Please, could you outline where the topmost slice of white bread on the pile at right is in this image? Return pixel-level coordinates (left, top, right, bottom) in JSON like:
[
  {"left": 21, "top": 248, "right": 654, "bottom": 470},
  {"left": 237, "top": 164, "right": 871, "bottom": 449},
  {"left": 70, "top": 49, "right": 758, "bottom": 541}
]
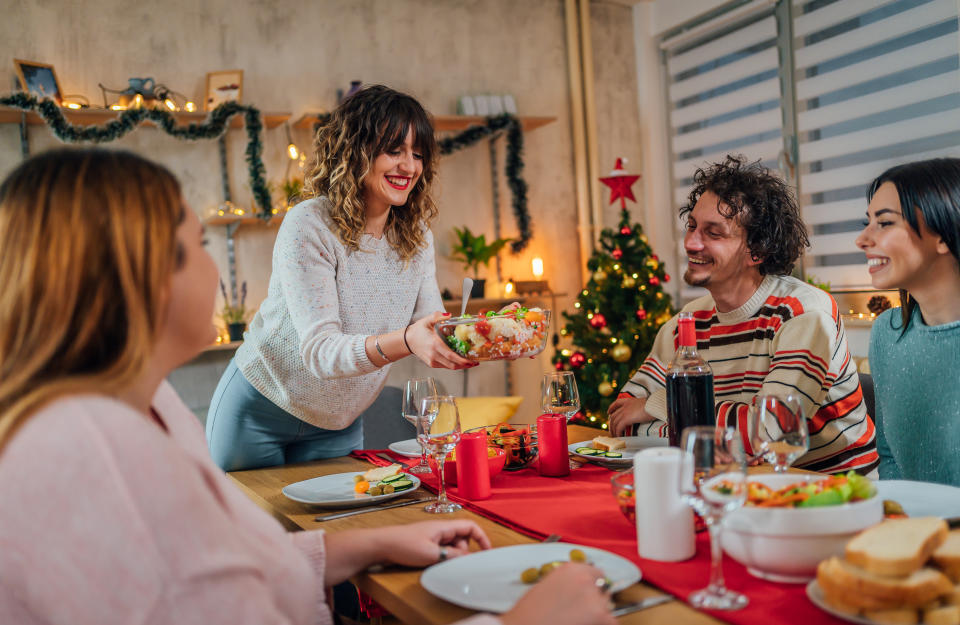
[{"left": 846, "top": 517, "right": 947, "bottom": 576}]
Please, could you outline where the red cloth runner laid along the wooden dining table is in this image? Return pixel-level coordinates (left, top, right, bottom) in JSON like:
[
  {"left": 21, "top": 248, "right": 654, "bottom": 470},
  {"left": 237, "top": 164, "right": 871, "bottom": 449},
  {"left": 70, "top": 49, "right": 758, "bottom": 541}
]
[{"left": 351, "top": 450, "right": 844, "bottom": 625}]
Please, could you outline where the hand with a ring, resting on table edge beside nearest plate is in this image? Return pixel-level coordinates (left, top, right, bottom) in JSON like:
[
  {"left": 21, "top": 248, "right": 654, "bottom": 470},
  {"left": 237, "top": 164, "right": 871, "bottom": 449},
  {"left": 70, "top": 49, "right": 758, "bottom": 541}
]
[{"left": 381, "top": 520, "right": 490, "bottom": 567}]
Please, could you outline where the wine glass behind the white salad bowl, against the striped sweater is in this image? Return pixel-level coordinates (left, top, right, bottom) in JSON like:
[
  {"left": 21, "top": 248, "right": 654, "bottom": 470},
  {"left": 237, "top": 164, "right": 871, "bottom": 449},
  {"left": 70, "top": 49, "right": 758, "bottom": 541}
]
[{"left": 747, "top": 395, "right": 810, "bottom": 473}]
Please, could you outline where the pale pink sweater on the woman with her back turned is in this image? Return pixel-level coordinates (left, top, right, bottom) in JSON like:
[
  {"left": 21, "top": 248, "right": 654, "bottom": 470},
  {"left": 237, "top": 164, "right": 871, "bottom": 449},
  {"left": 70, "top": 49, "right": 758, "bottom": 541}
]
[{"left": 0, "top": 383, "right": 499, "bottom": 625}]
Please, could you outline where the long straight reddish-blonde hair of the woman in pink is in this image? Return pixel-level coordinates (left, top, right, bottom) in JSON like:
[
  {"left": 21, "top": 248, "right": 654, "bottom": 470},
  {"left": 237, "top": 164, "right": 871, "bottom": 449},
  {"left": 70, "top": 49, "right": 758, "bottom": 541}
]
[{"left": 0, "top": 149, "right": 184, "bottom": 450}]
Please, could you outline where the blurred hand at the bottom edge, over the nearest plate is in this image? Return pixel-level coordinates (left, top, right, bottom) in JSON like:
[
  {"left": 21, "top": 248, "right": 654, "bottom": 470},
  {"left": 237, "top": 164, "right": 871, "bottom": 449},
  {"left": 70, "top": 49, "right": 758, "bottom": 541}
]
[{"left": 500, "top": 562, "right": 617, "bottom": 625}]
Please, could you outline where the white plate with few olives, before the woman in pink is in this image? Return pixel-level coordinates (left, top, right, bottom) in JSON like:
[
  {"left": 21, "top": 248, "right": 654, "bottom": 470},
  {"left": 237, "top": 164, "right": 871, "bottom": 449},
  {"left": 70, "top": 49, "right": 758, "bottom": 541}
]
[{"left": 420, "top": 543, "right": 640, "bottom": 613}]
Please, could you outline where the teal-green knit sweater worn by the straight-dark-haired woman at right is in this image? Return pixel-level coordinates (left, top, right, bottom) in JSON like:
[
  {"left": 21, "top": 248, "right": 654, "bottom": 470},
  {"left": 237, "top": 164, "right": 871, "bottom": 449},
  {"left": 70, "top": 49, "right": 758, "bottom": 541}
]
[{"left": 870, "top": 307, "right": 960, "bottom": 486}]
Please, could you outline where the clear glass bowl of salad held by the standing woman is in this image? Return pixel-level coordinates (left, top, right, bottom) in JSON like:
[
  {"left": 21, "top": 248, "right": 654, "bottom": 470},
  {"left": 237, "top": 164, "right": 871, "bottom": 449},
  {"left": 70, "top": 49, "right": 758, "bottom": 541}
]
[{"left": 434, "top": 306, "right": 550, "bottom": 361}]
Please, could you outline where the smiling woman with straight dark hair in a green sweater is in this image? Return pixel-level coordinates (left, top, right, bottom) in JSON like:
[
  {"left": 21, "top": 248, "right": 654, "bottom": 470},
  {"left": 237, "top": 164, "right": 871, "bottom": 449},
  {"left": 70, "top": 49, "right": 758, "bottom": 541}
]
[{"left": 857, "top": 158, "right": 960, "bottom": 486}]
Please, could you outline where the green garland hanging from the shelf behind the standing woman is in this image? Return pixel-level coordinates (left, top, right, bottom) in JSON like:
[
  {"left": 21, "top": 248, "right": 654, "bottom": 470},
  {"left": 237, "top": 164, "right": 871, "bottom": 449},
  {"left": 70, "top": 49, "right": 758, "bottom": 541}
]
[{"left": 314, "top": 113, "right": 533, "bottom": 254}]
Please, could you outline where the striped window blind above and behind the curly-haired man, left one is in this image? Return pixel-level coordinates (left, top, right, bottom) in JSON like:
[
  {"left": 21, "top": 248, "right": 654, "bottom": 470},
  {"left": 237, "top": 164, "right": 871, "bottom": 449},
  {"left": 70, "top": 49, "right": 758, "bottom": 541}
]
[{"left": 661, "top": 2, "right": 783, "bottom": 298}]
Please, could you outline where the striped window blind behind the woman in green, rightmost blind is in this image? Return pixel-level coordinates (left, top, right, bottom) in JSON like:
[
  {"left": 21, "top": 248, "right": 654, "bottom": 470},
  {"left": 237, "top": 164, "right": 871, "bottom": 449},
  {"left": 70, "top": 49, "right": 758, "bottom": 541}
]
[{"left": 792, "top": 0, "right": 960, "bottom": 288}]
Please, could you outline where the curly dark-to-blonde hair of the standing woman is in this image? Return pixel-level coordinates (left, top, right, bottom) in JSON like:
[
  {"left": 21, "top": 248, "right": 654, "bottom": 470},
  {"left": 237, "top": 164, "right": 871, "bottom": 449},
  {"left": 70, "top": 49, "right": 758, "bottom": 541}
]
[{"left": 304, "top": 85, "right": 438, "bottom": 262}]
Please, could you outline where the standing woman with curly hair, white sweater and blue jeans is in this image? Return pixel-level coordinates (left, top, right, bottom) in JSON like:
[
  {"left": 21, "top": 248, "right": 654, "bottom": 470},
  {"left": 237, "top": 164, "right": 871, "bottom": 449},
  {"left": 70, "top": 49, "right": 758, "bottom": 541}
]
[{"left": 207, "top": 85, "right": 474, "bottom": 471}]
